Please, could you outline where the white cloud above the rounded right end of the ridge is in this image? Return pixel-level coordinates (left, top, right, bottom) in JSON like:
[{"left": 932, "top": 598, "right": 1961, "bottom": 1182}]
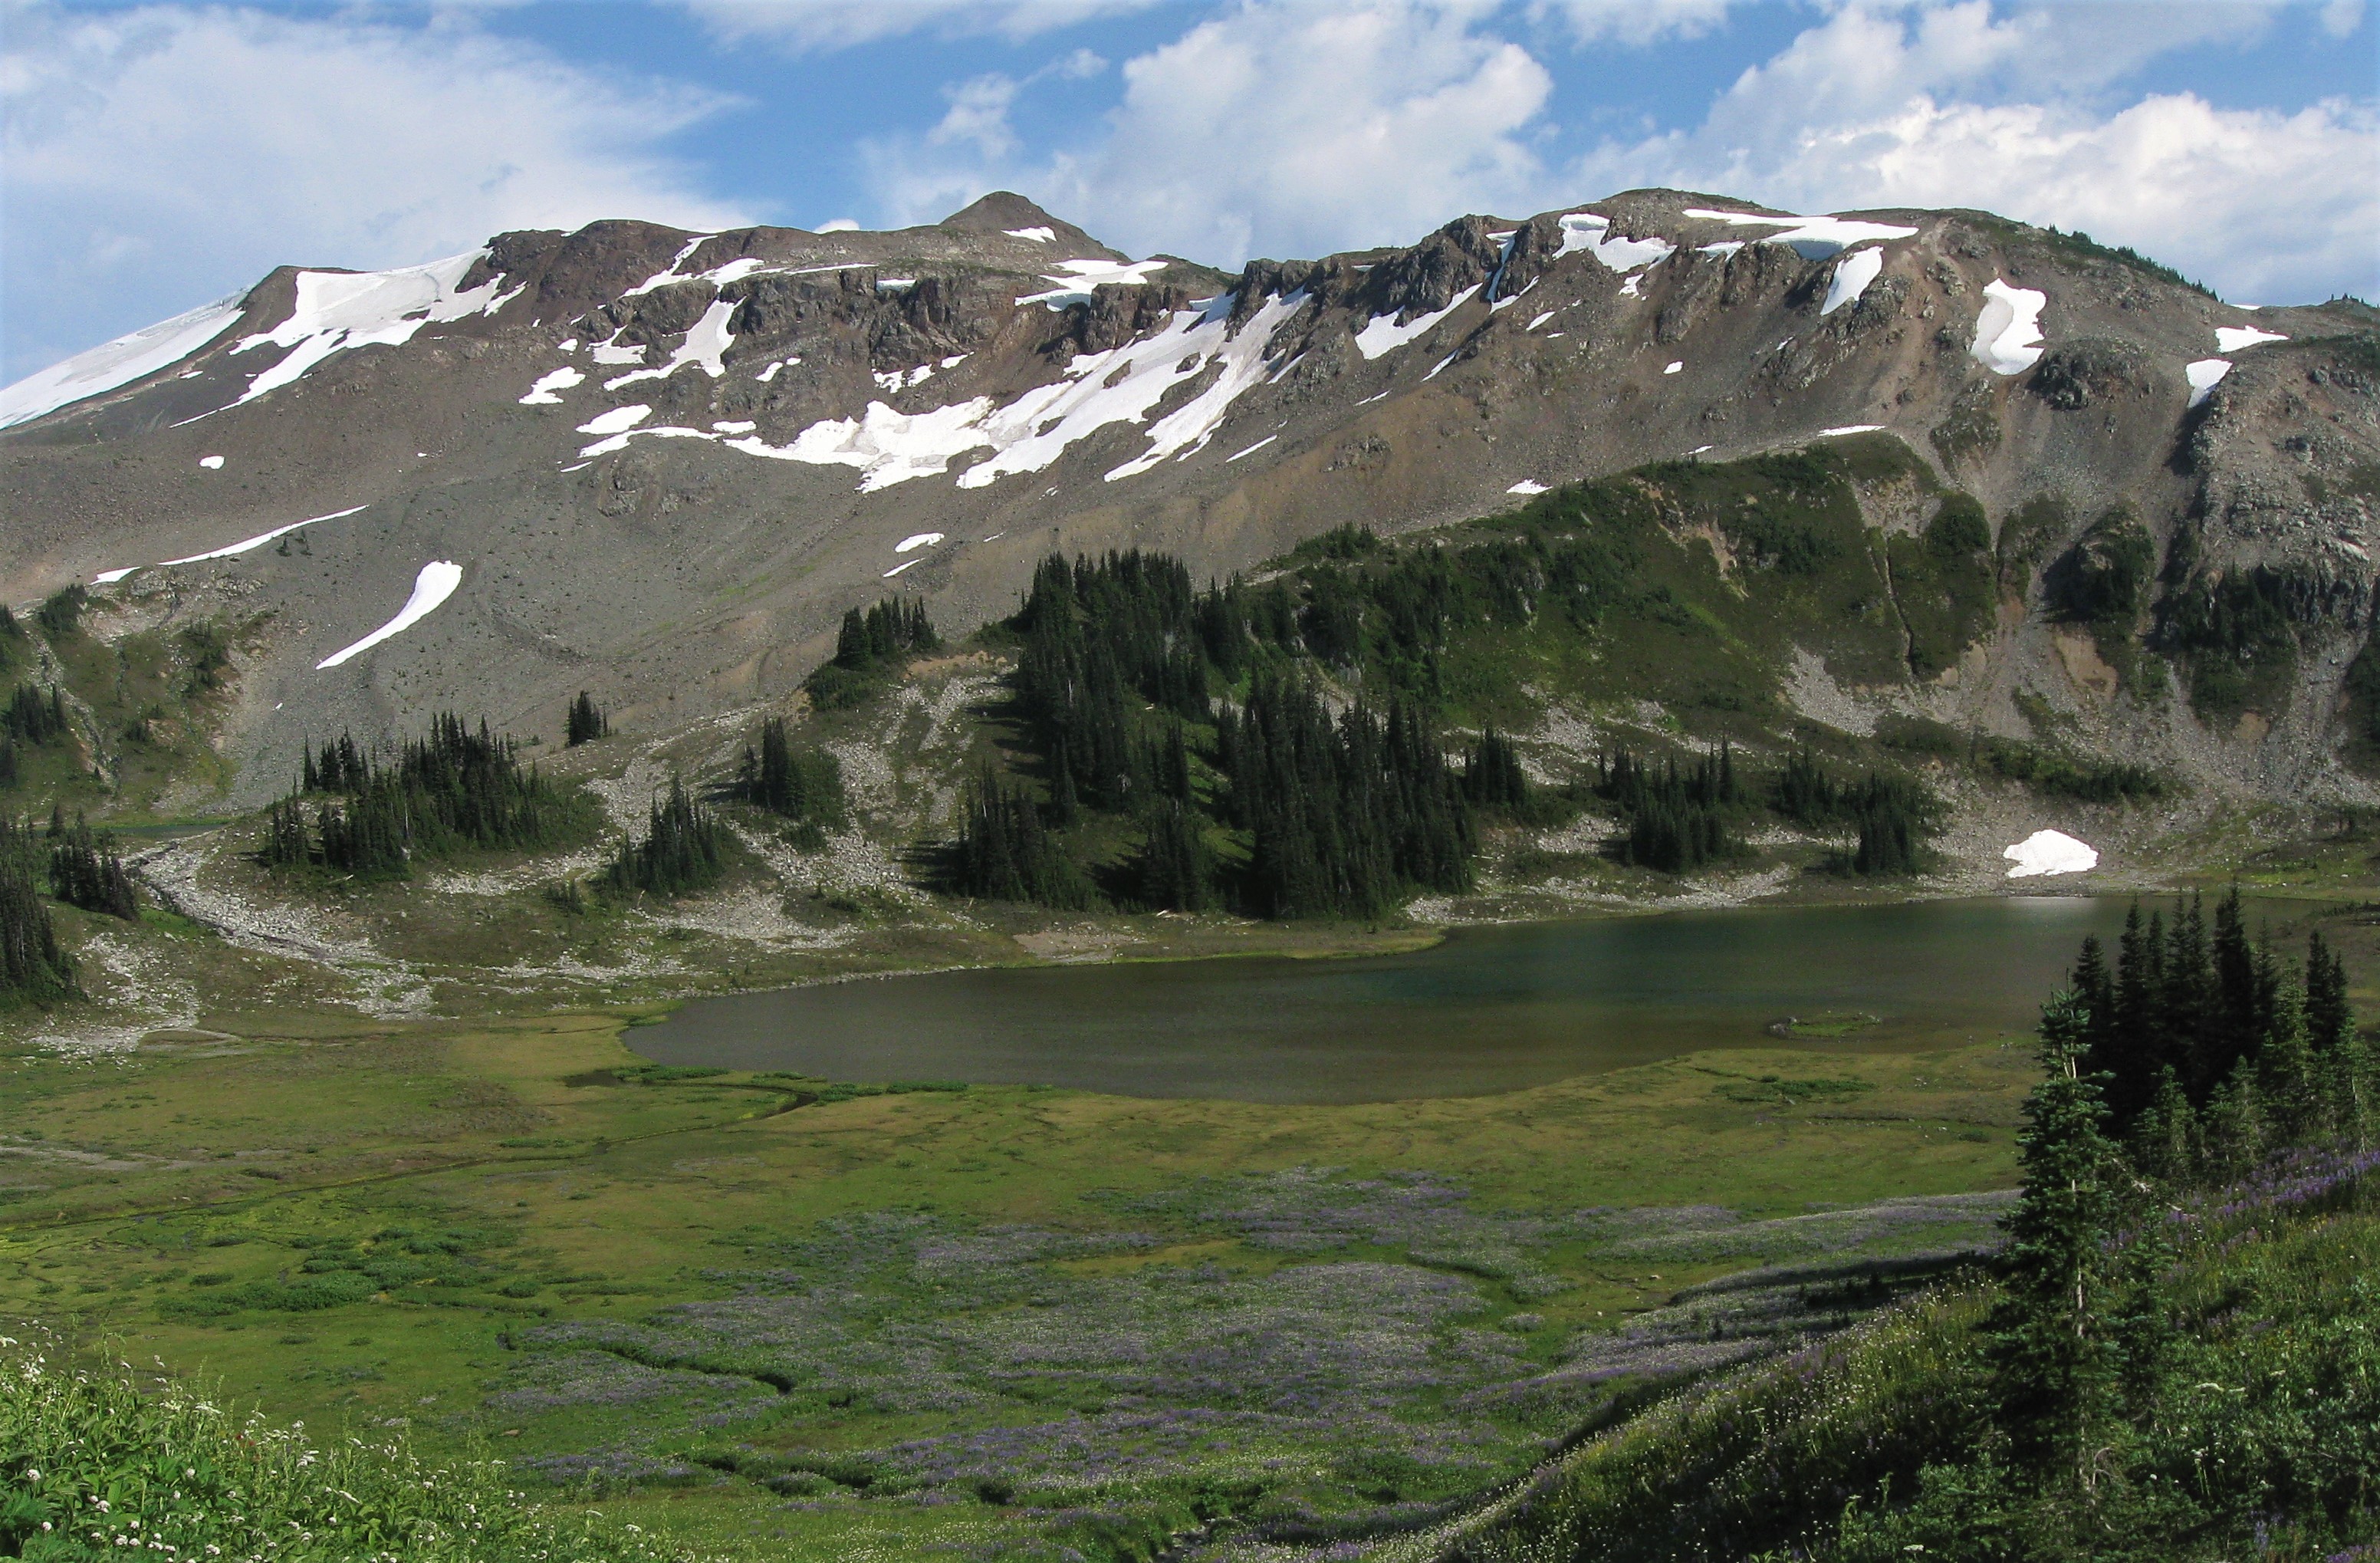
[{"left": 1573, "top": 5, "right": 2380, "bottom": 302}]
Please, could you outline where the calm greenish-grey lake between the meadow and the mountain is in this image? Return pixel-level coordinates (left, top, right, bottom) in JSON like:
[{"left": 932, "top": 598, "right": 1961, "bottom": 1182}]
[{"left": 633, "top": 897, "right": 2306, "bottom": 1101}]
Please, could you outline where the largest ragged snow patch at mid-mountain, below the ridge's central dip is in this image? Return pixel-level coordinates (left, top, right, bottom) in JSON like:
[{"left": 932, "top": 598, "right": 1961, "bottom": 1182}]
[{"left": 728, "top": 293, "right": 1307, "bottom": 492}]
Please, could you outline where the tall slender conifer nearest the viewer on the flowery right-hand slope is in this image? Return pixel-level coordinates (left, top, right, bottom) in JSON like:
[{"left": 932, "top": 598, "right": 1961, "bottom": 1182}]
[{"left": 1990, "top": 989, "right": 2113, "bottom": 1479}]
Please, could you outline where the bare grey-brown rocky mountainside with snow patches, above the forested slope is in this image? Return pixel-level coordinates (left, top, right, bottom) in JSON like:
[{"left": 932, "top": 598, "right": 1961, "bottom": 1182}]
[{"left": 0, "top": 190, "right": 2380, "bottom": 799}]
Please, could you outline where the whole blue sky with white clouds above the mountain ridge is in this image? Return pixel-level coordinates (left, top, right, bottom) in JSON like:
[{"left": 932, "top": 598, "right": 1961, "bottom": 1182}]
[{"left": 0, "top": 0, "right": 2380, "bottom": 380}]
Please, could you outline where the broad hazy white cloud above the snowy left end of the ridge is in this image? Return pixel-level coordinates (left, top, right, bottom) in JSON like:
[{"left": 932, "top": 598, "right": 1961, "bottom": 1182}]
[{"left": 0, "top": 7, "right": 750, "bottom": 380}]
